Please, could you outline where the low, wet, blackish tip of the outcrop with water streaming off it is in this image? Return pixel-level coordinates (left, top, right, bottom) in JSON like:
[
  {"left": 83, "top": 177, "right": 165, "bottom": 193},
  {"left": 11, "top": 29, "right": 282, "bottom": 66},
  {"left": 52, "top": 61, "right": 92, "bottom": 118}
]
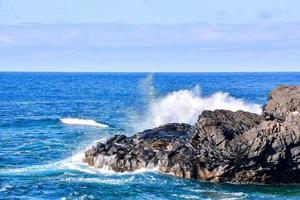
[{"left": 84, "top": 124, "right": 191, "bottom": 172}]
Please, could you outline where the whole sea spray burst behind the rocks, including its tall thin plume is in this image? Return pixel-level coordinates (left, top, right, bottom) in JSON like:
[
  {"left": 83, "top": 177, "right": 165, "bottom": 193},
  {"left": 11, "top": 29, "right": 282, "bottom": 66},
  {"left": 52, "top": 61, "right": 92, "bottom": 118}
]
[{"left": 129, "top": 73, "right": 262, "bottom": 132}]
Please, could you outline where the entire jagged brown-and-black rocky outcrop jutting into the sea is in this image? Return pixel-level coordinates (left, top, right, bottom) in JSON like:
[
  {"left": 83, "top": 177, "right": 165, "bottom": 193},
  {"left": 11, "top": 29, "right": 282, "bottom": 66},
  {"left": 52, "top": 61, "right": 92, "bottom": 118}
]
[{"left": 84, "top": 86, "right": 300, "bottom": 183}]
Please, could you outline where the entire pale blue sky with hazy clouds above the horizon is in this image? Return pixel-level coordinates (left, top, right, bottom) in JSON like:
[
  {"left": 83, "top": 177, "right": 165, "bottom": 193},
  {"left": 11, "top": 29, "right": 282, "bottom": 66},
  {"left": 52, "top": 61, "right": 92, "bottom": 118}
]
[{"left": 0, "top": 0, "right": 300, "bottom": 72}]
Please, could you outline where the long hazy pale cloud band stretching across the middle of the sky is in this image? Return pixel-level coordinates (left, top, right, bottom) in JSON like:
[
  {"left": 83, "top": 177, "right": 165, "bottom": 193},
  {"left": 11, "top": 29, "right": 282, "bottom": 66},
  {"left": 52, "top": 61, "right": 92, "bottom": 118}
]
[{"left": 0, "top": 22, "right": 300, "bottom": 51}]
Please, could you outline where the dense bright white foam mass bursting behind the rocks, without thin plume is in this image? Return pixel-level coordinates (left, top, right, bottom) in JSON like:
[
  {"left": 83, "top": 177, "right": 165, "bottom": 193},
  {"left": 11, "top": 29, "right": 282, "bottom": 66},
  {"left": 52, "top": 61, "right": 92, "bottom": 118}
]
[{"left": 150, "top": 86, "right": 262, "bottom": 126}]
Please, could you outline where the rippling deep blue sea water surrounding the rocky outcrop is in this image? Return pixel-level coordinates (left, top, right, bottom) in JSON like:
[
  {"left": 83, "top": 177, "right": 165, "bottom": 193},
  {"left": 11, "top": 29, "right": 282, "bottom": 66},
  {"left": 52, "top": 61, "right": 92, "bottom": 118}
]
[{"left": 0, "top": 72, "right": 300, "bottom": 200}]
